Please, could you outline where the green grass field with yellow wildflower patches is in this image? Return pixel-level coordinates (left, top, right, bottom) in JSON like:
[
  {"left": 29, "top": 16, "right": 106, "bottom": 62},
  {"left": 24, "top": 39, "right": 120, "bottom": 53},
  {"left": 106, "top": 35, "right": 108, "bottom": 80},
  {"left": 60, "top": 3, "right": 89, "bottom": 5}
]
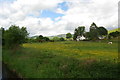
[{"left": 3, "top": 41, "right": 118, "bottom": 78}]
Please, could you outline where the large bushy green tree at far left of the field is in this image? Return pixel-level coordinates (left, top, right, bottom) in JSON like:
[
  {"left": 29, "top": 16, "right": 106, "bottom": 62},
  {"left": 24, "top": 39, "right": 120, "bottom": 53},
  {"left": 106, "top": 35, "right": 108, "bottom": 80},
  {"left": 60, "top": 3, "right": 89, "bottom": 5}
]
[{"left": 4, "top": 25, "right": 28, "bottom": 48}]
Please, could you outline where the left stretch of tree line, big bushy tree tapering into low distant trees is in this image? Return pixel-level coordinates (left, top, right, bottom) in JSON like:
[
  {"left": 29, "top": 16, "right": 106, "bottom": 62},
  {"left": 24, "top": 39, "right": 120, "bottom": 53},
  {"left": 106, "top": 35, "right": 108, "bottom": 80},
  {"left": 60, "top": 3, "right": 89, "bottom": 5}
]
[{"left": 0, "top": 25, "right": 65, "bottom": 48}]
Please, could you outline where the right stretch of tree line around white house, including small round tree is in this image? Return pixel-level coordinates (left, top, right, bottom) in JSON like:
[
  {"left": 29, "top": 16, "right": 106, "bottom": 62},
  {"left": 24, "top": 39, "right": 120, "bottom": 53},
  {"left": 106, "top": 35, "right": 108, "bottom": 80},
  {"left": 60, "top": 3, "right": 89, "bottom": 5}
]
[{"left": 66, "top": 22, "right": 120, "bottom": 41}]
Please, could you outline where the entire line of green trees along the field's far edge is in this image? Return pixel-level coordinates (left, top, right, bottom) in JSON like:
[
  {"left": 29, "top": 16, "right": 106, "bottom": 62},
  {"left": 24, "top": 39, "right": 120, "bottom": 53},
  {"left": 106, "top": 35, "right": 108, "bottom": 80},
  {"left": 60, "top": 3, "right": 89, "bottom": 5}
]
[{"left": 0, "top": 22, "right": 120, "bottom": 48}]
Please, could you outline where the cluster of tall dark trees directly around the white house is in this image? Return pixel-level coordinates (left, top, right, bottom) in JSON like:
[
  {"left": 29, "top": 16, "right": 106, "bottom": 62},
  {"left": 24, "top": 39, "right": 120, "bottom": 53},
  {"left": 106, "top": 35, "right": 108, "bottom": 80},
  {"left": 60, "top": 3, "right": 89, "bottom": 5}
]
[{"left": 73, "top": 22, "right": 108, "bottom": 40}]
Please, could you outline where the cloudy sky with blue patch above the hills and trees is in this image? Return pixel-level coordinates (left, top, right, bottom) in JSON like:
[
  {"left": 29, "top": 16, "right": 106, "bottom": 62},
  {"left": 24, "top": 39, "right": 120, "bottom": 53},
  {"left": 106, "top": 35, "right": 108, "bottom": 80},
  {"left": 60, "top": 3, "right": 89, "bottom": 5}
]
[{"left": 0, "top": 0, "right": 119, "bottom": 36}]
